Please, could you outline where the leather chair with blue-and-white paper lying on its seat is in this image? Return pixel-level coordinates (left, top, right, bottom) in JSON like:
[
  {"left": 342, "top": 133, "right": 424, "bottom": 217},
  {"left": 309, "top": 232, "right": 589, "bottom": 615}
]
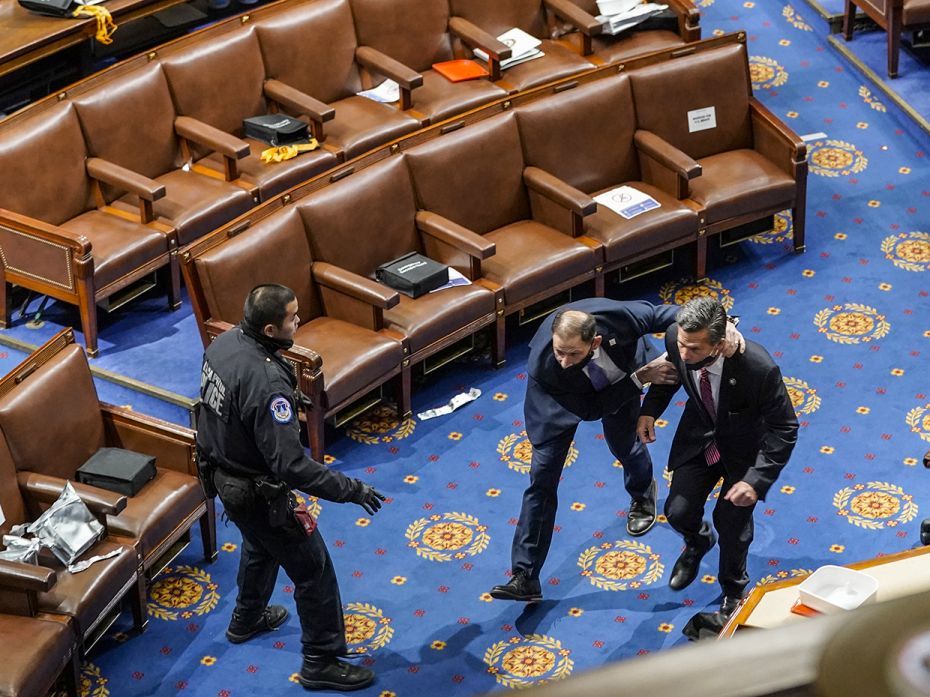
[{"left": 516, "top": 75, "right": 698, "bottom": 278}]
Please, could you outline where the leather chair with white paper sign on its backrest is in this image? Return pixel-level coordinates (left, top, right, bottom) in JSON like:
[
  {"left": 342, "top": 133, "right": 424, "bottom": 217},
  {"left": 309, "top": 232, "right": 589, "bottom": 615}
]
[{"left": 630, "top": 43, "right": 807, "bottom": 278}]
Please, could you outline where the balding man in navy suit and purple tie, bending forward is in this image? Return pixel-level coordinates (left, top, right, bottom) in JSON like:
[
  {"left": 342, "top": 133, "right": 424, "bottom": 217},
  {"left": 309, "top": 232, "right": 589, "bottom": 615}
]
[{"left": 491, "top": 298, "right": 744, "bottom": 601}]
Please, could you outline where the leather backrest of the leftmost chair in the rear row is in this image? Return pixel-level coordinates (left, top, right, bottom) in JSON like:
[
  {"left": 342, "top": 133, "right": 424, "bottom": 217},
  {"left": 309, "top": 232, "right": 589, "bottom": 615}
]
[{"left": 0, "top": 101, "right": 94, "bottom": 225}]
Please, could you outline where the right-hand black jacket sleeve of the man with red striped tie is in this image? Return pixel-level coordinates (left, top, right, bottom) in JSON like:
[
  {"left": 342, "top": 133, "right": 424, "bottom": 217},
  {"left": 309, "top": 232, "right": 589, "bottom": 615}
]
[{"left": 743, "top": 364, "right": 798, "bottom": 499}]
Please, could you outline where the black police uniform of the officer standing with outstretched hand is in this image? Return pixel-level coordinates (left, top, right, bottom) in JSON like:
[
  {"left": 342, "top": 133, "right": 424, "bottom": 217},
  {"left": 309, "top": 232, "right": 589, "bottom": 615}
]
[{"left": 197, "top": 324, "right": 365, "bottom": 656}]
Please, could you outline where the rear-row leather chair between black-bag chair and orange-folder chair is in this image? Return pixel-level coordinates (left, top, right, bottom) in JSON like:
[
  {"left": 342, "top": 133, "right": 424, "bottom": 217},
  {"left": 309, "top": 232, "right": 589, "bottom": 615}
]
[{"left": 255, "top": 0, "right": 421, "bottom": 159}]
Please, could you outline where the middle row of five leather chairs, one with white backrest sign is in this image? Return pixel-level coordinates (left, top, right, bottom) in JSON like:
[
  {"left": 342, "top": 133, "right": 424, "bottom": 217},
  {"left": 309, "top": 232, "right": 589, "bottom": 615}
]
[{"left": 182, "top": 34, "right": 807, "bottom": 457}]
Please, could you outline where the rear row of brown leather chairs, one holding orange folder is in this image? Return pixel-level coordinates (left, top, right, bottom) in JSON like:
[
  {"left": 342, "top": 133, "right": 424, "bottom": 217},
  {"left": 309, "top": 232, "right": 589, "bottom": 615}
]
[{"left": 0, "top": 0, "right": 700, "bottom": 356}]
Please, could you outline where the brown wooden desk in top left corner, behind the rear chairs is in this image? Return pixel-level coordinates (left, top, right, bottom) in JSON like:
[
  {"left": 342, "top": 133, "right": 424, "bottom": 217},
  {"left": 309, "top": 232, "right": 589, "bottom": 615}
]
[{"left": 0, "top": 0, "right": 187, "bottom": 77}]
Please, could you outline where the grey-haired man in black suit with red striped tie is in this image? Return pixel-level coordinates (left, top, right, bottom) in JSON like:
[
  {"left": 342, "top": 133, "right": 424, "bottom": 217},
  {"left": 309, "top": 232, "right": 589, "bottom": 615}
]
[{"left": 637, "top": 298, "right": 798, "bottom": 615}]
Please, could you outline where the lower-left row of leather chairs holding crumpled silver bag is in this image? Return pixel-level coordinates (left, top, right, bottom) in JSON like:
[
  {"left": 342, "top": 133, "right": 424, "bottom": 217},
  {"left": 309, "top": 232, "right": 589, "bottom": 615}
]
[{"left": 0, "top": 329, "right": 216, "bottom": 697}]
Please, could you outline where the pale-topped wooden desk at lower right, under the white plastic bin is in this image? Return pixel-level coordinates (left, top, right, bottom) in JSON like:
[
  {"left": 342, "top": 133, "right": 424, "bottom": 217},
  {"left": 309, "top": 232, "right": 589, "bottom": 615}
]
[{"left": 720, "top": 547, "right": 930, "bottom": 638}]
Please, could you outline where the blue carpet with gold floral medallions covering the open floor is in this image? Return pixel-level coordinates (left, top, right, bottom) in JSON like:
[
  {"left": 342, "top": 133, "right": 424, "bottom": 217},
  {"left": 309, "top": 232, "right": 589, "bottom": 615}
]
[{"left": 7, "top": 0, "right": 930, "bottom": 697}]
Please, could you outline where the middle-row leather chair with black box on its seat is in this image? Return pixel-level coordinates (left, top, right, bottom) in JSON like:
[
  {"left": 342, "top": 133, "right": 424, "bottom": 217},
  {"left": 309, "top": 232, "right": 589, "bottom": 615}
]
[{"left": 297, "top": 155, "right": 504, "bottom": 370}]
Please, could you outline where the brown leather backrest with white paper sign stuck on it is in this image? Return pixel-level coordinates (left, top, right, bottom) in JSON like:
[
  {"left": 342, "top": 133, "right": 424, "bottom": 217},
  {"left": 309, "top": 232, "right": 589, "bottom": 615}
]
[{"left": 630, "top": 44, "right": 753, "bottom": 160}]
